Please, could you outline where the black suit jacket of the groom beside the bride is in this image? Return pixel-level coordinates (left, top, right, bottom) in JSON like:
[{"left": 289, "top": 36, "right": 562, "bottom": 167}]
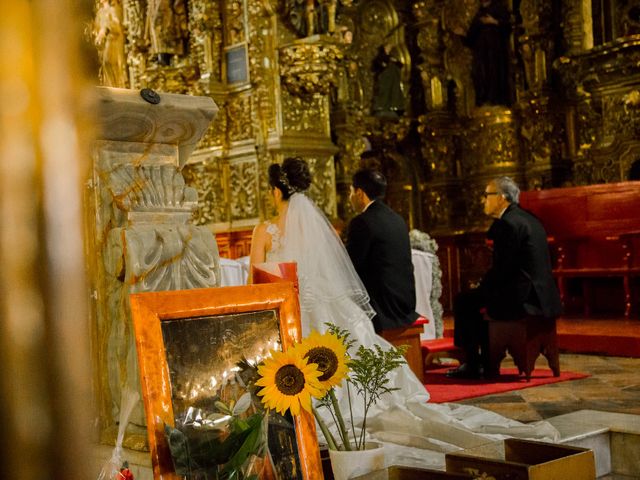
[{"left": 347, "top": 200, "right": 419, "bottom": 332}]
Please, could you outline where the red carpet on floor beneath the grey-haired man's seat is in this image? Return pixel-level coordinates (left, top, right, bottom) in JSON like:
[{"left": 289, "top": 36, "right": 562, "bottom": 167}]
[{"left": 424, "top": 366, "right": 589, "bottom": 403}]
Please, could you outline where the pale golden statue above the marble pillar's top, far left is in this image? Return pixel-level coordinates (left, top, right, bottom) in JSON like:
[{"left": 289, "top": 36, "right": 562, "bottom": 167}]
[{"left": 93, "top": 0, "right": 127, "bottom": 88}]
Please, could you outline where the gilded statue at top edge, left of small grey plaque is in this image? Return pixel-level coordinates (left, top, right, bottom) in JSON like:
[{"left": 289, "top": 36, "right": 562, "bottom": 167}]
[{"left": 145, "top": 0, "right": 189, "bottom": 66}]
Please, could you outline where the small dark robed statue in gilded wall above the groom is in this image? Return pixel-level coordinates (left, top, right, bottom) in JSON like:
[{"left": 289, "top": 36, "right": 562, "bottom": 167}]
[{"left": 371, "top": 43, "right": 405, "bottom": 118}]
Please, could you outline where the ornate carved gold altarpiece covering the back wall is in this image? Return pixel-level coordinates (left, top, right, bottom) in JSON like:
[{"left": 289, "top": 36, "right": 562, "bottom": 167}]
[{"left": 94, "top": 0, "right": 640, "bottom": 238}]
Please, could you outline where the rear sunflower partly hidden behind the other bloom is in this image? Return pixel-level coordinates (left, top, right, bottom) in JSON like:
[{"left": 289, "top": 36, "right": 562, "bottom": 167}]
[{"left": 295, "top": 330, "right": 349, "bottom": 390}]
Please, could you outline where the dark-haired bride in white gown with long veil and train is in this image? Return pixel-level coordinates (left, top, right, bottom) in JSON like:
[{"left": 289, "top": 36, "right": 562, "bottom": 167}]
[{"left": 250, "top": 158, "right": 558, "bottom": 461}]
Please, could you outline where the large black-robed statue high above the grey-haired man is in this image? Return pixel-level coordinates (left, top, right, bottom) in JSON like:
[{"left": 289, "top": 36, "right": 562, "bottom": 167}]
[{"left": 454, "top": 0, "right": 513, "bottom": 106}]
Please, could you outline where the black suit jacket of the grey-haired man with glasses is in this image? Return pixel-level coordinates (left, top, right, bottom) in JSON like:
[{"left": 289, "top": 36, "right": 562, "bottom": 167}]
[{"left": 479, "top": 204, "right": 562, "bottom": 320}]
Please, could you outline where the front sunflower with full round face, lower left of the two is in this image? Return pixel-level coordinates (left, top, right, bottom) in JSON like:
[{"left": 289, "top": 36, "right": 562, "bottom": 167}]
[{"left": 256, "top": 348, "right": 323, "bottom": 415}]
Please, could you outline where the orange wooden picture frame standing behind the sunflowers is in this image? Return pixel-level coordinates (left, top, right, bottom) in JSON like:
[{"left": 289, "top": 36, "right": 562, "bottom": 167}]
[{"left": 130, "top": 282, "right": 323, "bottom": 480}]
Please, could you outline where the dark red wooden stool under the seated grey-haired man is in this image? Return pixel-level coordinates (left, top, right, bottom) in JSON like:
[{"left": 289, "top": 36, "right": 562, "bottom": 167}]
[{"left": 485, "top": 316, "right": 560, "bottom": 381}]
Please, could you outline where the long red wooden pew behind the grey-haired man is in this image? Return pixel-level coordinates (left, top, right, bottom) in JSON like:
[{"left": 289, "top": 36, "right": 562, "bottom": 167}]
[{"left": 520, "top": 182, "right": 640, "bottom": 317}]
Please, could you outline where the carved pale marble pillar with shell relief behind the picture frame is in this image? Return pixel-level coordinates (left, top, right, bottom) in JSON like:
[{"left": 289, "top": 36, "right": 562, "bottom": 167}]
[{"left": 87, "top": 88, "right": 220, "bottom": 449}]
